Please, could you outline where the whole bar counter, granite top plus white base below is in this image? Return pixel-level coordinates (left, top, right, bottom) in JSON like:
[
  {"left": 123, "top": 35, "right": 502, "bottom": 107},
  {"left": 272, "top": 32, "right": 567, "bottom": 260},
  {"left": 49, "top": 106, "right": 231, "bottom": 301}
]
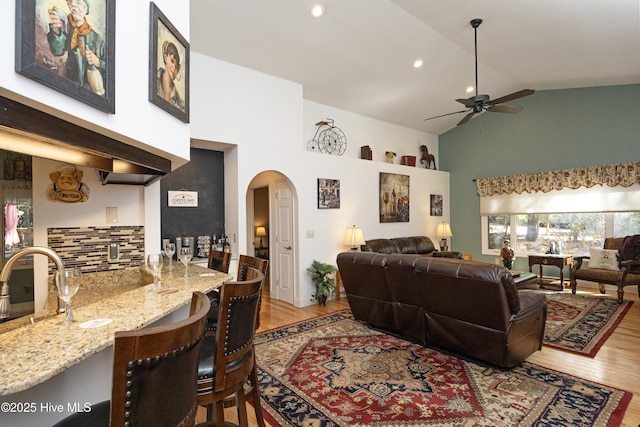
[{"left": 0, "top": 263, "right": 232, "bottom": 426}]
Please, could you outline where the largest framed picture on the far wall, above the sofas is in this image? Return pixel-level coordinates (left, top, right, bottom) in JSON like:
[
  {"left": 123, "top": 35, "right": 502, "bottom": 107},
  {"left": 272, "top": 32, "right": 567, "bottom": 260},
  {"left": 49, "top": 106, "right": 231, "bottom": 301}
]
[{"left": 378, "top": 172, "right": 409, "bottom": 222}]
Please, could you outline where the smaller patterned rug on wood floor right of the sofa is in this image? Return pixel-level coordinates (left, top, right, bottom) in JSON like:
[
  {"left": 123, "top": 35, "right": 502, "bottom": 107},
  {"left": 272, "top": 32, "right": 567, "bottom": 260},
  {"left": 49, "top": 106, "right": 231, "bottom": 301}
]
[{"left": 544, "top": 292, "right": 633, "bottom": 357}]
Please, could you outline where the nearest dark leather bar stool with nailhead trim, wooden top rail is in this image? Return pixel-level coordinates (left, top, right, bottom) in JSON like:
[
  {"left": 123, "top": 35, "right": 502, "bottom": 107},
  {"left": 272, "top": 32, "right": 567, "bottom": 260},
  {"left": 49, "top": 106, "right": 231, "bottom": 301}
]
[{"left": 54, "top": 292, "right": 209, "bottom": 427}]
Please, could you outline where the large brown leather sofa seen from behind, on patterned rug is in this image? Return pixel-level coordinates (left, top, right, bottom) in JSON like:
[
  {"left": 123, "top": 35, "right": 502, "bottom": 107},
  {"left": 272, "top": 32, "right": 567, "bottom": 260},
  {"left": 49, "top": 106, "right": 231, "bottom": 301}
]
[{"left": 337, "top": 252, "right": 547, "bottom": 368}]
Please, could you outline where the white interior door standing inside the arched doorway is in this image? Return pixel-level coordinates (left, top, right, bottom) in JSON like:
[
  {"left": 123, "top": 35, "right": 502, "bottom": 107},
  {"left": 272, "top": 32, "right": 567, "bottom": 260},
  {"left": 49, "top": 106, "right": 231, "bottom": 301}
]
[{"left": 275, "top": 180, "right": 296, "bottom": 304}]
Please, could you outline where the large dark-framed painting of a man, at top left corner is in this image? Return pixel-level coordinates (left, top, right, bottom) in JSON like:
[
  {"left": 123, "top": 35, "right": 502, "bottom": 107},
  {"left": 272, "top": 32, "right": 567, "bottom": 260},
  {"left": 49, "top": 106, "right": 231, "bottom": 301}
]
[{"left": 16, "top": 0, "right": 116, "bottom": 113}]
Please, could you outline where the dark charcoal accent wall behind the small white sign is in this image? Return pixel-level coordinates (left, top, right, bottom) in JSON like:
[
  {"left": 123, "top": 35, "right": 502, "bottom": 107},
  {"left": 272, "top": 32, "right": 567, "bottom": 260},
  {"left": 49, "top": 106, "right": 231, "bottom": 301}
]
[{"left": 160, "top": 148, "right": 225, "bottom": 241}]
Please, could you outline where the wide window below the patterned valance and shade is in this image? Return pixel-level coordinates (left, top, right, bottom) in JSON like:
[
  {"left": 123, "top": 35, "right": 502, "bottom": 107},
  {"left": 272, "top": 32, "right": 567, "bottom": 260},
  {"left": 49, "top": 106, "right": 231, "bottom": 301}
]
[{"left": 481, "top": 212, "right": 640, "bottom": 254}]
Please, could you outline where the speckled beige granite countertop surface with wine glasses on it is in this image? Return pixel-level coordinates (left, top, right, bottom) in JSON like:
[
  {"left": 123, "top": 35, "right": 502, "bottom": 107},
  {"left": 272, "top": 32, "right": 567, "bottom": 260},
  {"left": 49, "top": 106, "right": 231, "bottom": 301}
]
[{"left": 0, "top": 263, "right": 232, "bottom": 395}]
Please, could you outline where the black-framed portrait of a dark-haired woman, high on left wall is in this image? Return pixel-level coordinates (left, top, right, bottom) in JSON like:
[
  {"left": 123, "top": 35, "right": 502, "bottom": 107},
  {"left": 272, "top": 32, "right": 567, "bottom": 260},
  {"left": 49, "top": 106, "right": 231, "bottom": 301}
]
[{"left": 149, "top": 2, "right": 189, "bottom": 123}]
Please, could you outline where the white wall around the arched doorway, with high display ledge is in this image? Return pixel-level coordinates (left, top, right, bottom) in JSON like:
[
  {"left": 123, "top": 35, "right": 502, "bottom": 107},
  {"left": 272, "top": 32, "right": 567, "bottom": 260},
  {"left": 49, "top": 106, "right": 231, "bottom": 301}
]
[{"left": 191, "top": 53, "right": 449, "bottom": 305}]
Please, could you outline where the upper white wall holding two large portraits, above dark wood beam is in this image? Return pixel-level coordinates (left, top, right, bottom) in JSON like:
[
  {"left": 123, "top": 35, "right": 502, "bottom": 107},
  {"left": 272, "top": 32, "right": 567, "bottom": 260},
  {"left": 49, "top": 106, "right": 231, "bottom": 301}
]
[{"left": 0, "top": 0, "right": 189, "bottom": 168}]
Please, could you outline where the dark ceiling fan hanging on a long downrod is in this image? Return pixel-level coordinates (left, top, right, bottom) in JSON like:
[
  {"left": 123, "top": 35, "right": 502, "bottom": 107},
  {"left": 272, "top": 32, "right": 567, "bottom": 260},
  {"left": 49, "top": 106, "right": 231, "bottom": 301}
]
[{"left": 425, "top": 19, "right": 535, "bottom": 126}]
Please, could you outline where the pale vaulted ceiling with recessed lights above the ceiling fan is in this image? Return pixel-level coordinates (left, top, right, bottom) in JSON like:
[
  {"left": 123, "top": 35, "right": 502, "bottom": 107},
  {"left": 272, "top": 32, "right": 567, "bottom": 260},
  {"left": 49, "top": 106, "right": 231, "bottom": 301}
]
[{"left": 189, "top": 0, "right": 640, "bottom": 134}]
